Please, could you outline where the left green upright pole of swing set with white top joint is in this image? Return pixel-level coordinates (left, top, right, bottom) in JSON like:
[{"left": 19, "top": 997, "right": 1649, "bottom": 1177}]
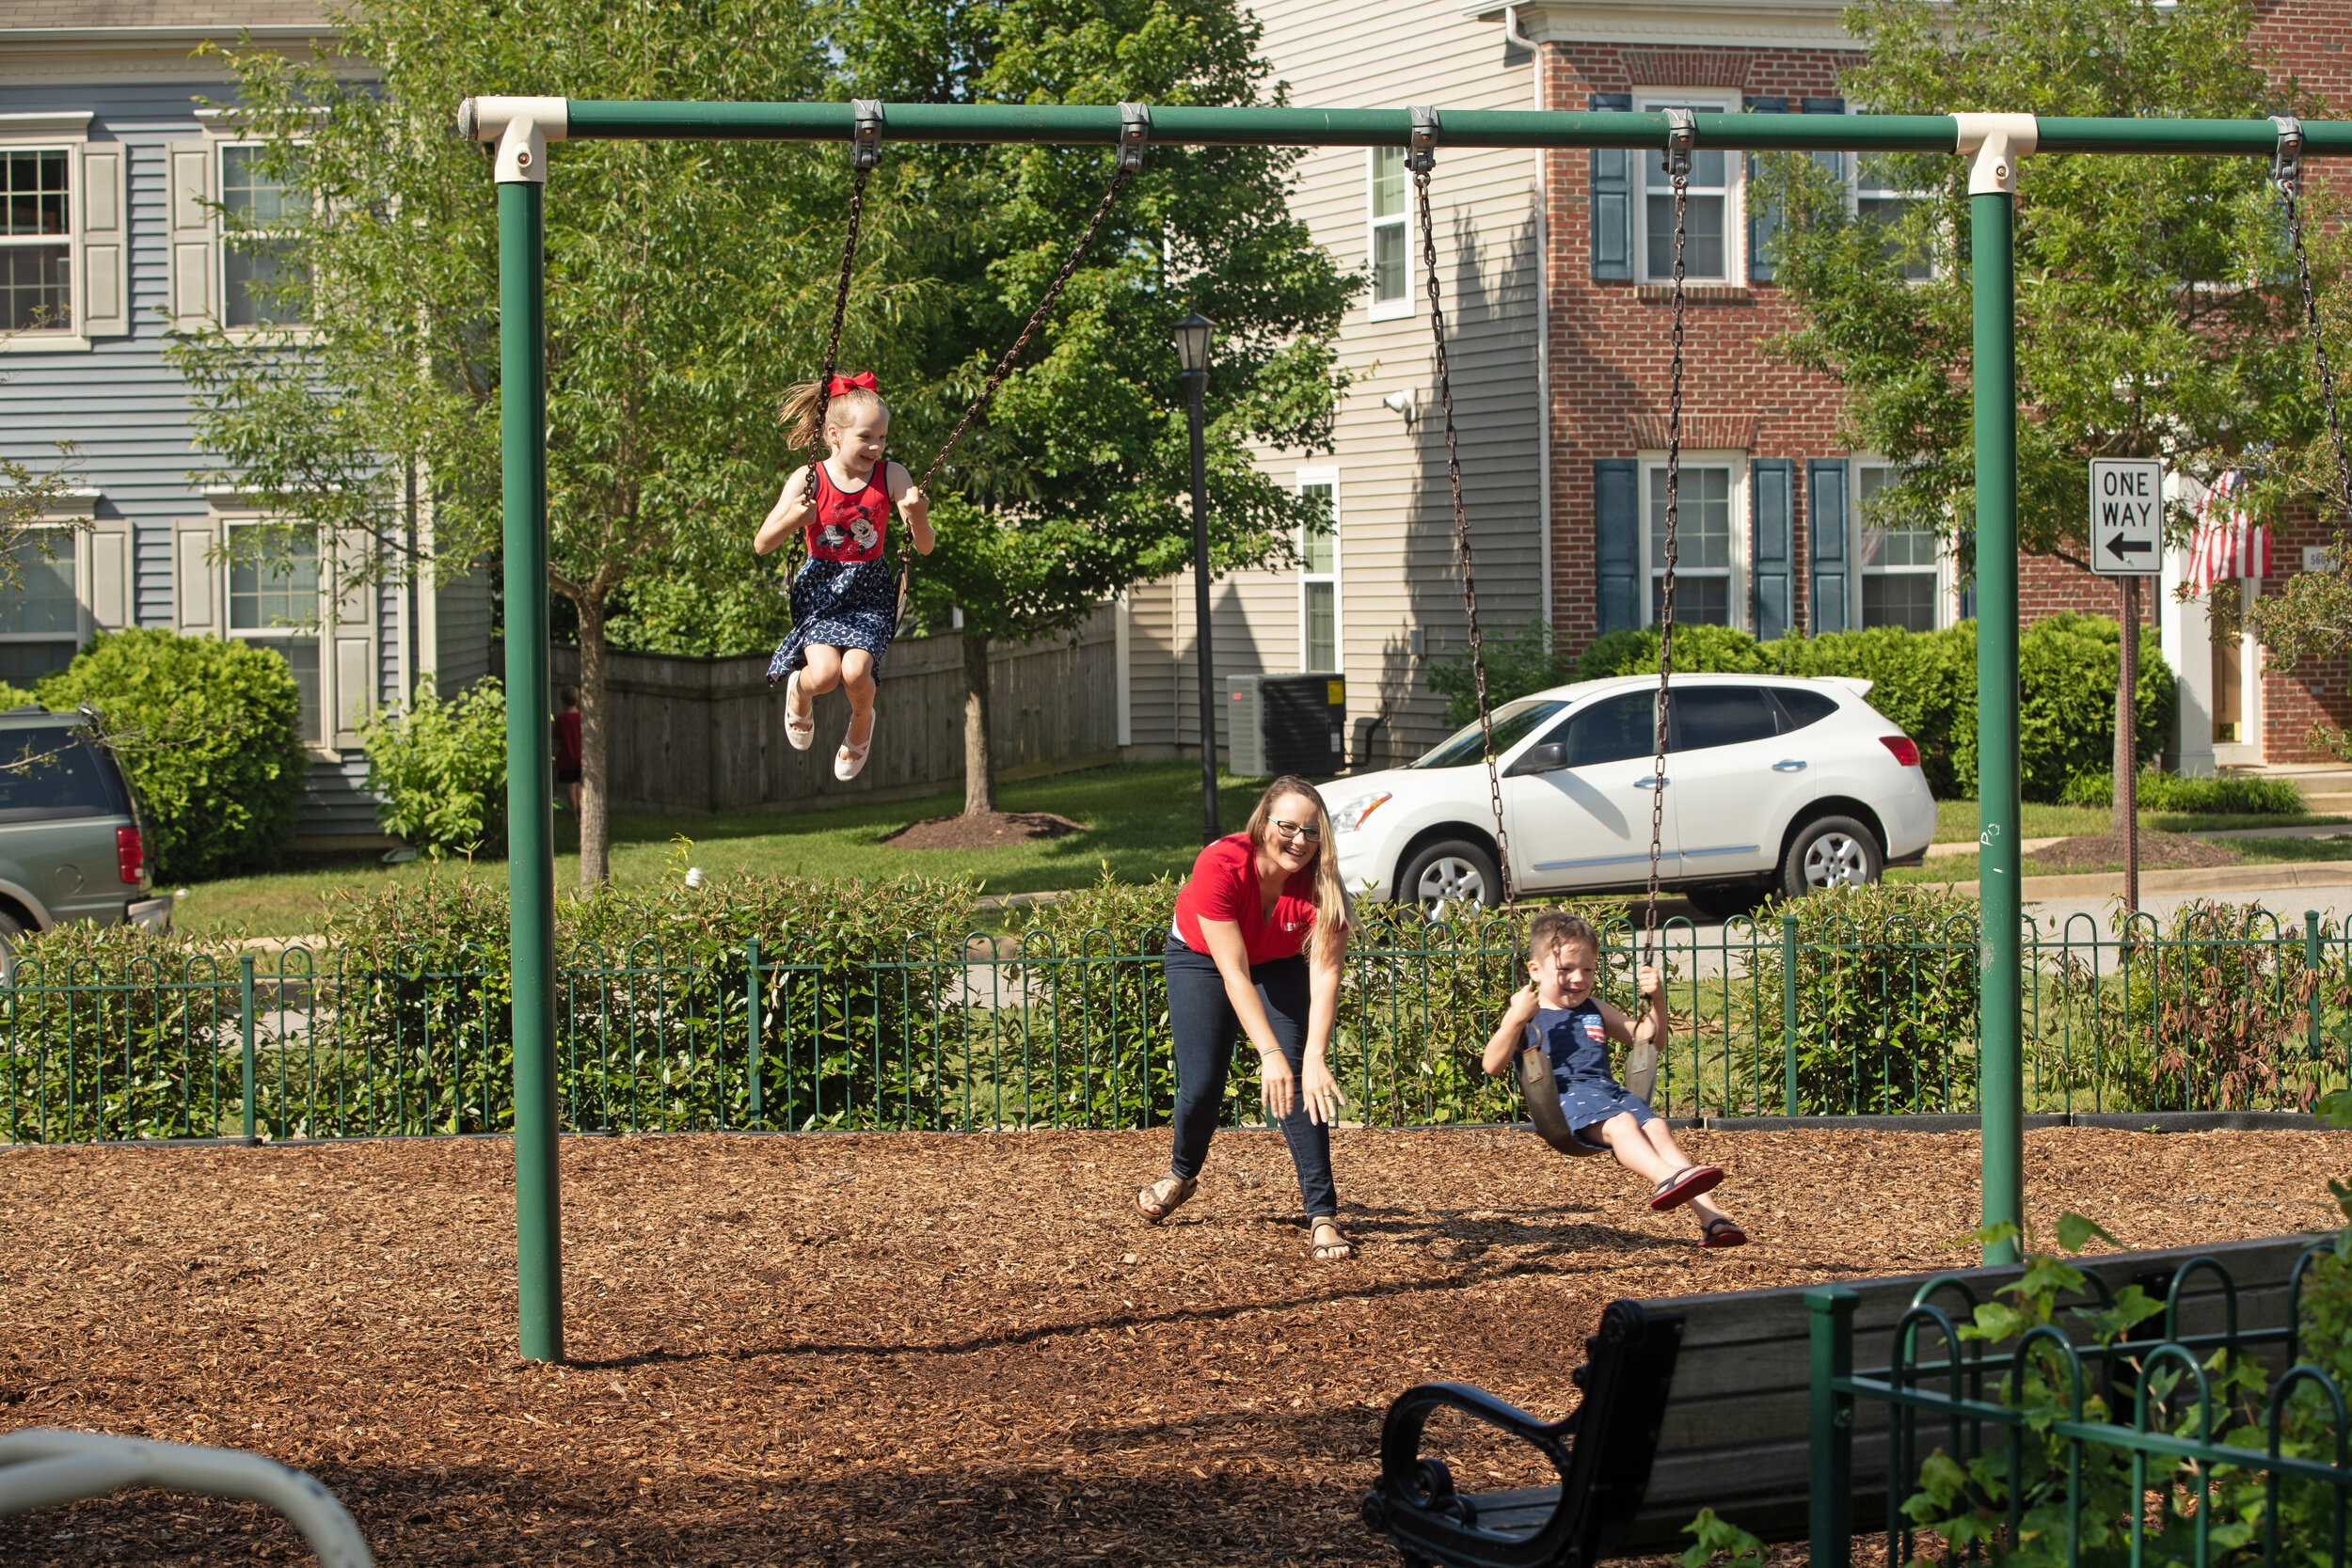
[{"left": 497, "top": 99, "right": 564, "bottom": 1361}]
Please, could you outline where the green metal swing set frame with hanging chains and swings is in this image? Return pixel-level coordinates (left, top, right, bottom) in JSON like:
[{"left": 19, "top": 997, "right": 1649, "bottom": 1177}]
[{"left": 459, "top": 96, "right": 2352, "bottom": 1361}]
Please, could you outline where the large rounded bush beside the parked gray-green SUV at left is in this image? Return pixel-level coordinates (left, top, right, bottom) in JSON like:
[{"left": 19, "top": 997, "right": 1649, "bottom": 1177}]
[{"left": 40, "top": 630, "right": 310, "bottom": 881}]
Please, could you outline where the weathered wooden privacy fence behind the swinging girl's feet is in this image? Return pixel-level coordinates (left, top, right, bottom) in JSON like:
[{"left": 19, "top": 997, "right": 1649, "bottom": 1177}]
[{"left": 553, "top": 604, "right": 1120, "bottom": 811}]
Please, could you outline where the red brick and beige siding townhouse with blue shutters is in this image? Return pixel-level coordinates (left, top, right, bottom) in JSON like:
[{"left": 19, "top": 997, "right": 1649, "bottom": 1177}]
[{"left": 1120, "top": 0, "right": 2352, "bottom": 771}]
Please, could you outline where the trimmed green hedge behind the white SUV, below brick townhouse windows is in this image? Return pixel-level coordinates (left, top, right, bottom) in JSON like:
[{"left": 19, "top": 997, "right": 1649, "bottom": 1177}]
[{"left": 1468, "top": 613, "right": 2176, "bottom": 801}]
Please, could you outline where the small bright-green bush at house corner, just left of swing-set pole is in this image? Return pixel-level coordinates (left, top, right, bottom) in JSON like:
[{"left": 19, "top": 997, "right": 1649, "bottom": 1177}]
[{"left": 360, "top": 677, "right": 506, "bottom": 848}]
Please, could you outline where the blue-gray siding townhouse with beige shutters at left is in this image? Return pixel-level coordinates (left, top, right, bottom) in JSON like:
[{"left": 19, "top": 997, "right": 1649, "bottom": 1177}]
[{"left": 0, "top": 0, "right": 489, "bottom": 848}]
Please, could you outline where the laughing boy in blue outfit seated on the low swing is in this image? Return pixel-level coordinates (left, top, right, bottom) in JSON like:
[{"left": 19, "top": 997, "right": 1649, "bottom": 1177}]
[{"left": 1482, "top": 910, "right": 1748, "bottom": 1246}]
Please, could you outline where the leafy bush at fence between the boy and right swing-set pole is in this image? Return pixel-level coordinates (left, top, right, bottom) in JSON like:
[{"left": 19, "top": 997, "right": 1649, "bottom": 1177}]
[{"left": 1731, "top": 884, "right": 1979, "bottom": 1117}]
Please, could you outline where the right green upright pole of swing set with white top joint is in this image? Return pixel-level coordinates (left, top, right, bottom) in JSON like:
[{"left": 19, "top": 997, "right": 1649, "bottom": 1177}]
[{"left": 1960, "top": 115, "right": 2035, "bottom": 1262}]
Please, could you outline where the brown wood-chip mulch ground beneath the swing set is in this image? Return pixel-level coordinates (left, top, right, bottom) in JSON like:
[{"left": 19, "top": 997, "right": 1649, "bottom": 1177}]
[{"left": 0, "top": 1129, "right": 2352, "bottom": 1568}]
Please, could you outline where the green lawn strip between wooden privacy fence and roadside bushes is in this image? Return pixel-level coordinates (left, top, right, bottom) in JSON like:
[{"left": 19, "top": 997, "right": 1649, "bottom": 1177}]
[{"left": 172, "top": 762, "right": 1263, "bottom": 936}]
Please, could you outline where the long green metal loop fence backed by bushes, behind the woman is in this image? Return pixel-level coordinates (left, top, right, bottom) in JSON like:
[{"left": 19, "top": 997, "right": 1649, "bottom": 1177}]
[{"left": 0, "top": 908, "right": 2352, "bottom": 1143}]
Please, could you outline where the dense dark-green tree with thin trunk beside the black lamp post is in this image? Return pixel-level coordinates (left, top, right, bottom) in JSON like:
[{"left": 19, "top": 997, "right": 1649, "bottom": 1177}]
[{"left": 828, "top": 0, "right": 1359, "bottom": 814}]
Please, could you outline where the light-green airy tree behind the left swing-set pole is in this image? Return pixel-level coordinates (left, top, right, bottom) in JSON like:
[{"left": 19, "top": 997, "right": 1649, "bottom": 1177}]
[{"left": 172, "top": 0, "right": 856, "bottom": 881}]
